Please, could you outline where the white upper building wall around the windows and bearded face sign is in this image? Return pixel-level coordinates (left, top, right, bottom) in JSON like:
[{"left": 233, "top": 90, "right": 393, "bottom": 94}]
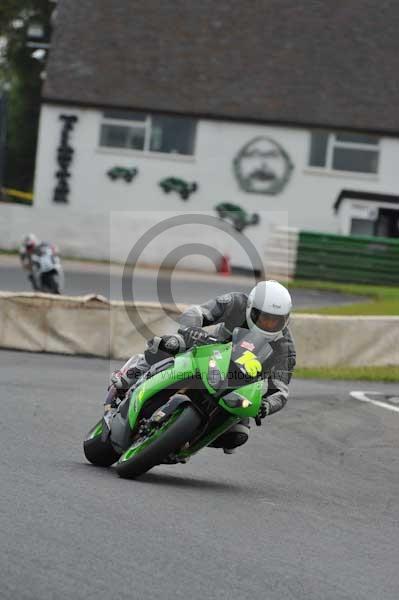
[{"left": 35, "top": 105, "right": 399, "bottom": 220}]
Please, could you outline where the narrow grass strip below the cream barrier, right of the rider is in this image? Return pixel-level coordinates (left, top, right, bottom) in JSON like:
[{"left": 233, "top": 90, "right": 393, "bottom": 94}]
[{"left": 294, "top": 366, "right": 399, "bottom": 382}]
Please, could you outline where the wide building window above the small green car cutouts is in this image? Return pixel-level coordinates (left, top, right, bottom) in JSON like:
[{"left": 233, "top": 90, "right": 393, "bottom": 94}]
[{"left": 100, "top": 110, "right": 197, "bottom": 156}]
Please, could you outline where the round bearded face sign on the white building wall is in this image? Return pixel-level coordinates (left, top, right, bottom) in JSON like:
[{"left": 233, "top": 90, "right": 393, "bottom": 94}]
[{"left": 233, "top": 137, "right": 294, "bottom": 194}]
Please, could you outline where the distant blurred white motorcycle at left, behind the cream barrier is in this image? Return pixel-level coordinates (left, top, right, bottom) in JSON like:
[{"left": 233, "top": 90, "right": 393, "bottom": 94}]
[{"left": 30, "top": 245, "right": 64, "bottom": 294}]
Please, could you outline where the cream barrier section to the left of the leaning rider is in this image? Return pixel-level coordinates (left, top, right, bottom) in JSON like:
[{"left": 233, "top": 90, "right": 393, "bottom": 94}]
[{"left": 0, "top": 292, "right": 180, "bottom": 359}]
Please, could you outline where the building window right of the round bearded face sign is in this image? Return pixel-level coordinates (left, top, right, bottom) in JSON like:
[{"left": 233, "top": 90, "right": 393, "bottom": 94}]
[{"left": 309, "top": 131, "right": 380, "bottom": 173}]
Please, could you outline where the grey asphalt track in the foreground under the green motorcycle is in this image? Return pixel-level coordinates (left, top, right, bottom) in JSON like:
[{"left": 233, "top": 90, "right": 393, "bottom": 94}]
[{"left": 0, "top": 350, "right": 399, "bottom": 600}]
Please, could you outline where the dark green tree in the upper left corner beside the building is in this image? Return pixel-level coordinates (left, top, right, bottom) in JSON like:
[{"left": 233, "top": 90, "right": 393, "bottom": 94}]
[{"left": 0, "top": 0, "right": 54, "bottom": 191}]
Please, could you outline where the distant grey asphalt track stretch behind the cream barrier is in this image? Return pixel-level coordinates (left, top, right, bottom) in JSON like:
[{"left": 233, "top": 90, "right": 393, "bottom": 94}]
[{"left": 0, "top": 256, "right": 364, "bottom": 308}]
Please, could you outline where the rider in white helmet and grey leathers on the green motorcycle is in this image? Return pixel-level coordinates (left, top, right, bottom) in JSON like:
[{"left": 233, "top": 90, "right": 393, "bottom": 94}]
[{"left": 108, "top": 280, "right": 296, "bottom": 454}]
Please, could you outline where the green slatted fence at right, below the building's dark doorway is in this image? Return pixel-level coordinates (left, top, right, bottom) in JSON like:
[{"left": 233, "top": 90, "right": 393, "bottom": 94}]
[{"left": 295, "top": 231, "right": 399, "bottom": 285}]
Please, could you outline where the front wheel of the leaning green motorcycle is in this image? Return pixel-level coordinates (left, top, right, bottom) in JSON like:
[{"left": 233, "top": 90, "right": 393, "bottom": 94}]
[{"left": 115, "top": 405, "right": 201, "bottom": 479}]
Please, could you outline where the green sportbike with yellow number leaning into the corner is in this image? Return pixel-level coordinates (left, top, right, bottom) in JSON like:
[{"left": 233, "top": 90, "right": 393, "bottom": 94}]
[{"left": 83, "top": 328, "right": 272, "bottom": 478}]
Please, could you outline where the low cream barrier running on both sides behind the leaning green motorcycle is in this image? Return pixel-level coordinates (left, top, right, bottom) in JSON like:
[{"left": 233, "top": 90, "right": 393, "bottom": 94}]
[{"left": 0, "top": 292, "right": 399, "bottom": 367}]
